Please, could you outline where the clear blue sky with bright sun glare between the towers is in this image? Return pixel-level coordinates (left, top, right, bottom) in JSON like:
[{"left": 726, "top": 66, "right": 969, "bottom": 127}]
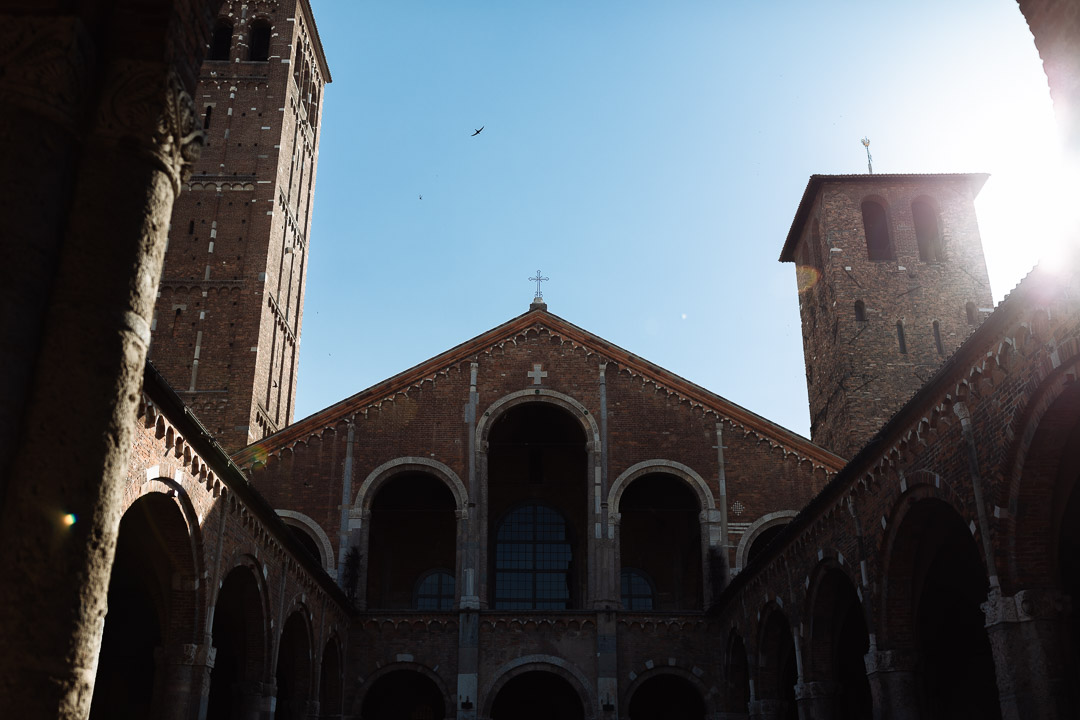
[{"left": 296, "top": 0, "right": 1075, "bottom": 435}]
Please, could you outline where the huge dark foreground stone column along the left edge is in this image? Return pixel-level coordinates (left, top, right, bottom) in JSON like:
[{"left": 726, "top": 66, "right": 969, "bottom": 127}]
[{"left": 0, "top": 12, "right": 203, "bottom": 720}]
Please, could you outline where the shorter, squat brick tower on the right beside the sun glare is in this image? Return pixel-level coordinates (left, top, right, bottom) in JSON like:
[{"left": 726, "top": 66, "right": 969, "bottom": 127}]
[{"left": 780, "top": 174, "right": 994, "bottom": 458}]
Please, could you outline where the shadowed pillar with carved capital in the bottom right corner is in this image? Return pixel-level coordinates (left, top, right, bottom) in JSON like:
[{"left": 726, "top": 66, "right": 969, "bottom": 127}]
[{"left": 982, "top": 589, "right": 1080, "bottom": 720}]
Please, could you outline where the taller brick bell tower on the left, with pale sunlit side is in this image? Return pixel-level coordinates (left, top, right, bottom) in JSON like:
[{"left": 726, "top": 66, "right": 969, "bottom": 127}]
[{"left": 150, "top": 0, "right": 330, "bottom": 451}]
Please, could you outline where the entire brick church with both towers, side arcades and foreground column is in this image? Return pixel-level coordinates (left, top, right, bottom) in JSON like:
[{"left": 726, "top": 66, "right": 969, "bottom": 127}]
[{"left": 0, "top": 0, "right": 1080, "bottom": 720}]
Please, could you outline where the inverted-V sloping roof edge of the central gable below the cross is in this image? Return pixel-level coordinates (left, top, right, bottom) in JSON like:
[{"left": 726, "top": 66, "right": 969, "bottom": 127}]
[{"left": 233, "top": 309, "right": 845, "bottom": 472}]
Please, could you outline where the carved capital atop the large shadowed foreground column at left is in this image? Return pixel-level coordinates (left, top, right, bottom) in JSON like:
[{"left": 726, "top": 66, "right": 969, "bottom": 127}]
[{"left": 95, "top": 60, "right": 203, "bottom": 192}]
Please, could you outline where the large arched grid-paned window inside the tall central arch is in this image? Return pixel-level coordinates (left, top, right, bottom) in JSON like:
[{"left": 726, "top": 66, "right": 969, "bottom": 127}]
[{"left": 495, "top": 505, "right": 572, "bottom": 610}]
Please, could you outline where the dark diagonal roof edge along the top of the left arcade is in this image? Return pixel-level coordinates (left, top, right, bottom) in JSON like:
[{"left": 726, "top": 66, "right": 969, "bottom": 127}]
[{"left": 143, "top": 361, "right": 353, "bottom": 614}]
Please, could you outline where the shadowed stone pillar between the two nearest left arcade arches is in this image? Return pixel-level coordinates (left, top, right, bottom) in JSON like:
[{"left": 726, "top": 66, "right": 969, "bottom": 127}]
[{"left": 152, "top": 643, "right": 217, "bottom": 720}]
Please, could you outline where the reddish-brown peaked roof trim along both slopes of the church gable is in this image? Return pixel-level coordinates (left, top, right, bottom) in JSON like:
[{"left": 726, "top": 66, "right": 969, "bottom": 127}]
[{"left": 233, "top": 307, "right": 845, "bottom": 473}]
